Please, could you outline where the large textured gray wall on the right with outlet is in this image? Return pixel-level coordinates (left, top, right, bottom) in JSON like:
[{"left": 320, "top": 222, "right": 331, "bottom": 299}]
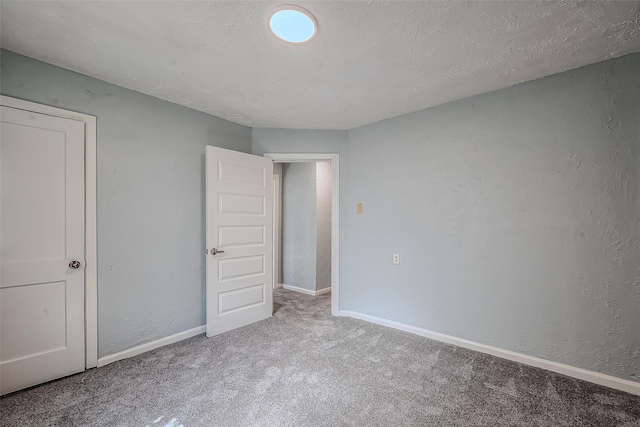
[{"left": 340, "top": 54, "right": 640, "bottom": 381}]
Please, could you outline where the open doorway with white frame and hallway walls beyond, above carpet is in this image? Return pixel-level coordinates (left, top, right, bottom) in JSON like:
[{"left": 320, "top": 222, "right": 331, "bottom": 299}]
[{"left": 264, "top": 153, "right": 340, "bottom": 316}]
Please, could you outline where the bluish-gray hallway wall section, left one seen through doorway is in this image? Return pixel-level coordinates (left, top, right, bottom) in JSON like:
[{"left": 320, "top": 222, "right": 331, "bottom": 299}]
[{"left": 282, "top": 163, "right": 317, "bottom": 291}]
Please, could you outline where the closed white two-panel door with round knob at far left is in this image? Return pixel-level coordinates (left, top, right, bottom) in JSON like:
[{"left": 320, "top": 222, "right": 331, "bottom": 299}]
[{"left": 0, "top": 107, "right": 85, "bottom": 394}]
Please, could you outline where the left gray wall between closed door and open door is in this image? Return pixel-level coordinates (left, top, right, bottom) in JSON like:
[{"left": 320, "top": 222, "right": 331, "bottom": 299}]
[{"left": 0, "top": 50, "right": 251, "bottom": 356}]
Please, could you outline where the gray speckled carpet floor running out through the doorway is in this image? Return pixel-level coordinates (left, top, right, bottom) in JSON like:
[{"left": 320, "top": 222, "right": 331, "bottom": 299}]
[{"left": 0, "top": 290, "right": 640, "bottom": 427}]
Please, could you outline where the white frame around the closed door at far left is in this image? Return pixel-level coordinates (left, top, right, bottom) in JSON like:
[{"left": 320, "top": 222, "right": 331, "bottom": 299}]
[{"left": 0, "top": 95, "right": 98, "bottom": 369}]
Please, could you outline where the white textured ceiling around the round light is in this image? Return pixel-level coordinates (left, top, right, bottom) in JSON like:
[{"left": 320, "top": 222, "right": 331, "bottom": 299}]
[{"left": 0, "top": 0, "right": 640, "bottom": 129}]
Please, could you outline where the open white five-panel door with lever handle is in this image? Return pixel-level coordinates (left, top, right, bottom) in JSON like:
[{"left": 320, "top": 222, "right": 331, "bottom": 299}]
[{"left": 206, "top": 146, "right": 273, "bottom": 337}]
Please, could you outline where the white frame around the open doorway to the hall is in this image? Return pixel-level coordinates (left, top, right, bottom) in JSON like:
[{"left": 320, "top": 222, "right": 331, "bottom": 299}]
[{"left": 264, "top": 153, "right": 340, "bottom": 316}]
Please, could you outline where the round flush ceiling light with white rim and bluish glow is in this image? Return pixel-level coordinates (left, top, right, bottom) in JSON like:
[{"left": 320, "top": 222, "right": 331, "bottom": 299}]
[{"left": 269, "top": 4, "right": 318, "bottom": 43}]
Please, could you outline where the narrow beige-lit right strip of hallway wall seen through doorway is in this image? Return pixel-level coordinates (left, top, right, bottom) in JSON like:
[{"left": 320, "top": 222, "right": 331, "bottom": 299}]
[{"left": 316, "top": 162, "right": 332, "bottom": 290}]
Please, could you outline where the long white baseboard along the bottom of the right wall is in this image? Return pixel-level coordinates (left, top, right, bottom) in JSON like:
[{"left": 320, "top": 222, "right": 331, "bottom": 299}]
[{"left": 340, "top": 310, "right": 640, "bottom": 396}]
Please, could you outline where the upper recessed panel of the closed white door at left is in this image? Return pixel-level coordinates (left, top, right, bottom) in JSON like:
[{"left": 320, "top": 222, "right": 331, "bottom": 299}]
[{"left": 2, "top": 120, "right": 66, "bottom": 262}]
